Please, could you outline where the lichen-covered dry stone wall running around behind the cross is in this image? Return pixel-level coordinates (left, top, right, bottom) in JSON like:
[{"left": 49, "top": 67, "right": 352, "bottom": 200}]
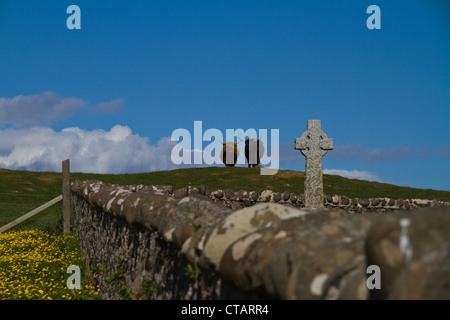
[{"left": 71, "top": 181, "right": 450, "bottom": 299}]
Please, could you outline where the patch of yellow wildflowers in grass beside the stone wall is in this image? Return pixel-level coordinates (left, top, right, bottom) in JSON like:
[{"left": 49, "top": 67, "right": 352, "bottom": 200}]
[{"left": 0, "top": 230, "right": 99, "bottom": 300}]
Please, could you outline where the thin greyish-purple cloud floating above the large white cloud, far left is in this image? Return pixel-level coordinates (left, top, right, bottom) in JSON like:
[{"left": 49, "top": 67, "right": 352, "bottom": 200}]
[{"left": 0, "top": 91, "right": 124, "bottom": 128}]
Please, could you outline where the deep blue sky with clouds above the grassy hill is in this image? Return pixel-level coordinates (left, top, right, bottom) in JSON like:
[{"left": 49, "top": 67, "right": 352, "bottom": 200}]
[{"left": 0, "top": 0, "right": 450, "bottom": 190}]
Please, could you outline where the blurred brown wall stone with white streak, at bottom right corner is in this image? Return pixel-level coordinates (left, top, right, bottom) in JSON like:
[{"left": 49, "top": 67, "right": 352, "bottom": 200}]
[{"left": 366, "top": 208, "right": 450, "bottom": 300}]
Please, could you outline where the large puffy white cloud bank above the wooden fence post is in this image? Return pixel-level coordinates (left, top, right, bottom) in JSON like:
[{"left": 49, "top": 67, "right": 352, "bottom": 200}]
[{"left": 0, "top": 125, "right": 181, "bottom": 173}]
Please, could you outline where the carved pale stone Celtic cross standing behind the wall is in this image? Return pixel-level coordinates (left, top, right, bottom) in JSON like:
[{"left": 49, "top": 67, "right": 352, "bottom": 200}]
[{"left": 295, "top": 120, "right": 333, "bottom": 208}]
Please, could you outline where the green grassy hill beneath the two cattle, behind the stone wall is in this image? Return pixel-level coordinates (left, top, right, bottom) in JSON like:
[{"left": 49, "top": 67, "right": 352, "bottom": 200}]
[{"left": 0, "top": 167, "right": 450, "bottom": 232}]
